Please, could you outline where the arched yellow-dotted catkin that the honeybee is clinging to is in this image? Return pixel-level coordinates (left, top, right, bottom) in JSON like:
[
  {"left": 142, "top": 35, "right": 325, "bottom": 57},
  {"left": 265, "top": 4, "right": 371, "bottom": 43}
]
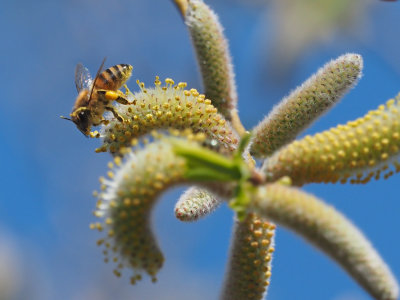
[{"left": 98, "top": 78, "right": 238, "bottom": 154}]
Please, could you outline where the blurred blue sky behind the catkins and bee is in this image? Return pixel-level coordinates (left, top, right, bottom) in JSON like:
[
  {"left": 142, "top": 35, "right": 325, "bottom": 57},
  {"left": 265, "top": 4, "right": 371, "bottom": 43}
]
[{"left": 0, "top": 0, "right": 400, "bottom": 300}]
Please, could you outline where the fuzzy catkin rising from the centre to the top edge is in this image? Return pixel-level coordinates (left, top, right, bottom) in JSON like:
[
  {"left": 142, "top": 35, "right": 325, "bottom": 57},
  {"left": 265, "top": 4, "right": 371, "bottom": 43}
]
[{"left": 184, "top": 0, "right": 237, "bottom": 120}]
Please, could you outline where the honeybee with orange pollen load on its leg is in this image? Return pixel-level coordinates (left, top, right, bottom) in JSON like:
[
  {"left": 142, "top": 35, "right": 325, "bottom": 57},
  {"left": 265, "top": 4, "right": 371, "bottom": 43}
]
[{"left": 61, "top": 59, "right": 132, "bottom": 136}]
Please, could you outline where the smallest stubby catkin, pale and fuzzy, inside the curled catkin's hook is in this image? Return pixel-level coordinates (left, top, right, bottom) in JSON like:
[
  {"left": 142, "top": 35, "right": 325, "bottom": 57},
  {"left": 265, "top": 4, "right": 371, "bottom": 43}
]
[{"left": 175, "top": 187, "right": 222, "bottom": 222}]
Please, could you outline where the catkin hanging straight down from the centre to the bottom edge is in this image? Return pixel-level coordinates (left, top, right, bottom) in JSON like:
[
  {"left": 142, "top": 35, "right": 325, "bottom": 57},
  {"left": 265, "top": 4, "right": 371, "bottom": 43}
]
[{"left": 221, "top": 214, "right": 275, "bottom": 300}]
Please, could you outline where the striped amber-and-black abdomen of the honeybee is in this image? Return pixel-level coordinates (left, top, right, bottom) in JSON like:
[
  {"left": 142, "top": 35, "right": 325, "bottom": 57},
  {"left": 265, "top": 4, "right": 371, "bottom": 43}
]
[{"left": 95, "top": 64, "right": 132, "bottom": 91}]
